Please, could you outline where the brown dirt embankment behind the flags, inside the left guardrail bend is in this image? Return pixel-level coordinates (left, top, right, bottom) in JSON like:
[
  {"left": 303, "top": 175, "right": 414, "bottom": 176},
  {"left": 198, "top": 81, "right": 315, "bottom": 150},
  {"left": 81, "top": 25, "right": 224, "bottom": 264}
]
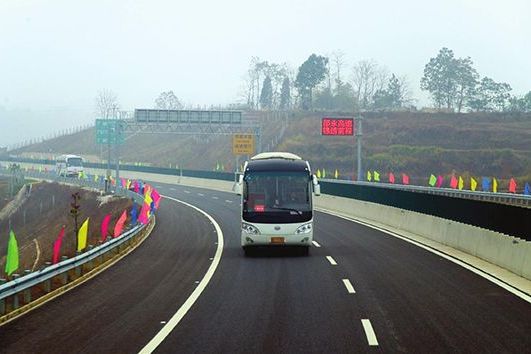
[{"left": 0, "top": 182, "right": 132, "bottom": 276}]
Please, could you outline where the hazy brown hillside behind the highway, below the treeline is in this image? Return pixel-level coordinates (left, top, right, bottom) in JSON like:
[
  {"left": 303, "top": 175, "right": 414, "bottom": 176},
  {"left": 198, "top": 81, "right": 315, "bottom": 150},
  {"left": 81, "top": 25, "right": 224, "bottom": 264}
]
[{"left": 11, "top": 112, "right": 531, "bottom": 180}]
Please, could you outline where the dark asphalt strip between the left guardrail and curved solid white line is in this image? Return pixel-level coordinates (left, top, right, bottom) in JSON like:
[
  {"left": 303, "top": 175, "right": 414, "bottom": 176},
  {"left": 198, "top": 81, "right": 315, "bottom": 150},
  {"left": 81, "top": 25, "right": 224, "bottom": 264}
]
[{"left": 0, "top": 199, "right": 217, "bottom": 353}]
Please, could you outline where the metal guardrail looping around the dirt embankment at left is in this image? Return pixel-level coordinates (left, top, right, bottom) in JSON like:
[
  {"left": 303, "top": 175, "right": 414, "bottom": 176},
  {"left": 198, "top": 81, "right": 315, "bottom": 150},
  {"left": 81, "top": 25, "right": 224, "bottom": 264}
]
[{"left": 0, "top": 168, "right": 152, "bottom": 323}]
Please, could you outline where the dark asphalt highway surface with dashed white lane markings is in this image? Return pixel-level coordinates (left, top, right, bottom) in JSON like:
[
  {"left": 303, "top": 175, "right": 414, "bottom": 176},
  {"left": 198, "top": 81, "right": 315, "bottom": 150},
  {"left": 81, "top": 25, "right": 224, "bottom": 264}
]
[{"left": 0, "top": 183, "right": 531, "bottom": 353}]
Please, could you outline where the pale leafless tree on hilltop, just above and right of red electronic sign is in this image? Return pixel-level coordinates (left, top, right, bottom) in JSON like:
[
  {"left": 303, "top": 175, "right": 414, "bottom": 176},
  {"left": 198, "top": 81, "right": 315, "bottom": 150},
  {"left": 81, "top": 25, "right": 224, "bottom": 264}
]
[{"left": 352, "top": 60, "right": 389, "bottom": 109}]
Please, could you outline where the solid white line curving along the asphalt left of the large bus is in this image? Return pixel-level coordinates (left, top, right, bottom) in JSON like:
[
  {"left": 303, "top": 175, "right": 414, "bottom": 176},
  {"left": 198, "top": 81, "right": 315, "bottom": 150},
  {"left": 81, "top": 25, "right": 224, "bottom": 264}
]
[{"left": 140, "top": 195, "right": 223, "bottom": 354}]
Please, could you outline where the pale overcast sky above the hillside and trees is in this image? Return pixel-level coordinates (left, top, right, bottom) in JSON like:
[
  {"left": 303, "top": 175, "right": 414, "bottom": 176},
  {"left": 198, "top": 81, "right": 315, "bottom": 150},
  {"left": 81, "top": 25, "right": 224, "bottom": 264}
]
[{"left": 0, "top": 0, "right": 531, "bottom": 146}]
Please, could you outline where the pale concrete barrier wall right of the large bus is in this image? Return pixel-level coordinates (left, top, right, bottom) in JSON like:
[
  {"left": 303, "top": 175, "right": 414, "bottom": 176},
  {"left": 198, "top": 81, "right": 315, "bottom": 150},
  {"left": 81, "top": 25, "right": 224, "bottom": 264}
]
[{"left": 314, "top": 195, "right": 531, "bottom": 280}]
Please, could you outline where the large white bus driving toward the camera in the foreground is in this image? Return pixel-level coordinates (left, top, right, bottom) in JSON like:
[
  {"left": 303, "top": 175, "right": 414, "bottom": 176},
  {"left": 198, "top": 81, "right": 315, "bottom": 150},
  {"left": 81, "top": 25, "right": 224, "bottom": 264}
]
[{"left": 235, "top": 152, "right": 320, "bottom": 255}]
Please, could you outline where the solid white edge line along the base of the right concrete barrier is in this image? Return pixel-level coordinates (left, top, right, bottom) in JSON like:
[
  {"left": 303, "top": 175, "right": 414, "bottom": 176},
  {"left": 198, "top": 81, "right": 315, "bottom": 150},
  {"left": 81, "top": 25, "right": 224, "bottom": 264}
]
[{"left": 316, "top": 208, "right": 531, "bottom": 303}]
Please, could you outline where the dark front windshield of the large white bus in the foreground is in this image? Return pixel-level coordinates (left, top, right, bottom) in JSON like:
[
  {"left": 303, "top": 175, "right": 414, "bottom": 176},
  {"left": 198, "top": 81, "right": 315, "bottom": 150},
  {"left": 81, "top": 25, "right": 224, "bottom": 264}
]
[{"left": 242, "top": 171, "right": 312, "bottom": 223}]
